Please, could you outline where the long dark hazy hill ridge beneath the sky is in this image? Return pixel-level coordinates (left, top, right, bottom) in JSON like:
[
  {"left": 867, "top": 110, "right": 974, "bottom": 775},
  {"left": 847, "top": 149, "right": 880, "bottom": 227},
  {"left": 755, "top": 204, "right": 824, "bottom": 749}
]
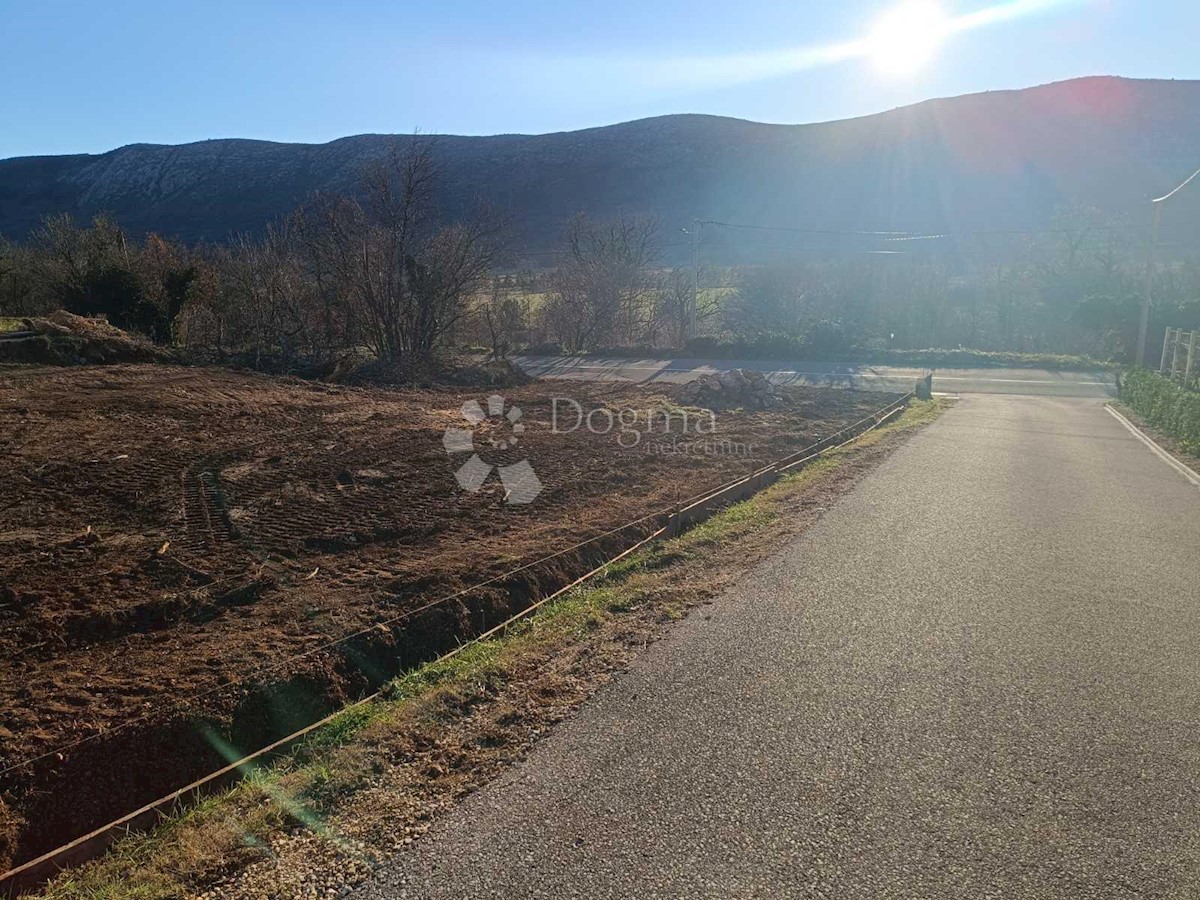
[{"left": 0, "top": 78, "right": 1200, "bottom": 260}]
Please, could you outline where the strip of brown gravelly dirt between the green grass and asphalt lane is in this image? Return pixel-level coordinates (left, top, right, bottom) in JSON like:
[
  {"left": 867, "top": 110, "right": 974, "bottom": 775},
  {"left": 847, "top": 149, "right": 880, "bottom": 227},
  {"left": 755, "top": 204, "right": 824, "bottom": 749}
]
[{"left": 100, "top": 415, "right": 936, "bottom": 900}]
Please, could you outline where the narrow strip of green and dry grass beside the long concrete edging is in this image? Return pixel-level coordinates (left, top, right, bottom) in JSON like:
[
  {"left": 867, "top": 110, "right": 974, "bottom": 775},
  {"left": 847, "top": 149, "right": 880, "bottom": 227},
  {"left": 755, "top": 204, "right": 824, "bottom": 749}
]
[{"left": 35, "top": 400, "right": 948, "bottom": 900}]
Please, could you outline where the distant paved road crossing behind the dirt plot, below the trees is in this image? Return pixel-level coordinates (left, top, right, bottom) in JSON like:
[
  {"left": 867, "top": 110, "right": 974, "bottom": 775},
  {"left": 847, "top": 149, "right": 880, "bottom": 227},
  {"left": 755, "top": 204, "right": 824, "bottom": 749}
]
[{"left": 516, "top": 356, "right": 1116, "bottom": 397}]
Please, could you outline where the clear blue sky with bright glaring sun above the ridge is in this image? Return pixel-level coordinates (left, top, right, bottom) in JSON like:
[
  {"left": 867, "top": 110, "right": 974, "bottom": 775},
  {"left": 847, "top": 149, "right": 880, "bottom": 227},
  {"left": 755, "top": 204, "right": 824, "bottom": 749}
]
[{"left": 0, "top": 0, "right": 1200, "bottom": 158}]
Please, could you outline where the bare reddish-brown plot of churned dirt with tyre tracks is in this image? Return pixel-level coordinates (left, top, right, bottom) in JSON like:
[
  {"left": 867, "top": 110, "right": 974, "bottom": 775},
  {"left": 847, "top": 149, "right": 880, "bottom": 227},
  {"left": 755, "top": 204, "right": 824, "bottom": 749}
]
[{"left": 0, "top": 365, "right": 892, "bottom": 869}]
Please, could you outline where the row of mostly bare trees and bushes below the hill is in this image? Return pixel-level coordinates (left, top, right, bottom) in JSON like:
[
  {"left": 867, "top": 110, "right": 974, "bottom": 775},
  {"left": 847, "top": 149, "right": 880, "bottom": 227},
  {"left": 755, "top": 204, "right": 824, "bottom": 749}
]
[{"left": 0, "top": 142, "right": 1200, "bottom": 362}]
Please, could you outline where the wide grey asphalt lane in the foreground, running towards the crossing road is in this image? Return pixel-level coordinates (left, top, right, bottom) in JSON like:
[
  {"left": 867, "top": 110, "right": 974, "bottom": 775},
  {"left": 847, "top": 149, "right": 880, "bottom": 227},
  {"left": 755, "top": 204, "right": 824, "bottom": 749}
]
[{"left": 356, "top": 395, "right": 1200, "bottom": 900}]
